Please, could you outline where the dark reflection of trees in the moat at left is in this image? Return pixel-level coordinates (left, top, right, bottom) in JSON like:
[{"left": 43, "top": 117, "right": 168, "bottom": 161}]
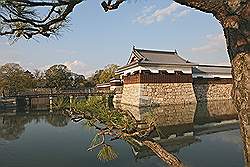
[{"left": 0, "top": 111, "right": 69, "bottom": 140}]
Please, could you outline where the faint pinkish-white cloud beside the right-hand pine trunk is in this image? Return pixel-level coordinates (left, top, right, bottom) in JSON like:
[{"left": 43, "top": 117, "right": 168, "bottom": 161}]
[{"left": 191, "top": 33, "right": 226, "bottom": 53}]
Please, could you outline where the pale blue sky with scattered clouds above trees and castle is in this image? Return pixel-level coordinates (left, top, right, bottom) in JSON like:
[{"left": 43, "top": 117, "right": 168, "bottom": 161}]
[{"left": 0, "top": 0, "right": 229, "bottom": 76}]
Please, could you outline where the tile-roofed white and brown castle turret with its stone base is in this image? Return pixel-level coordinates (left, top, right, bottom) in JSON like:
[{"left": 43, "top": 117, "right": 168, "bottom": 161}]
[{"left": 117, "top": 48, "right": 196, "bottom": 107}]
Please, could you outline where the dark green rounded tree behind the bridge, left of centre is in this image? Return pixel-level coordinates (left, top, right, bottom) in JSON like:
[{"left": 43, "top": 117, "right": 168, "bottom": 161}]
[{"left": 45, "top": 64, "right": 72, "bottom": 90}]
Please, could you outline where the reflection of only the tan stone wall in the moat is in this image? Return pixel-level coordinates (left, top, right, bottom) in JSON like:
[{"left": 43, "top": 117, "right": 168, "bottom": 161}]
[{"left": 121, "top": 100, "right": 237, "bottom": 126}]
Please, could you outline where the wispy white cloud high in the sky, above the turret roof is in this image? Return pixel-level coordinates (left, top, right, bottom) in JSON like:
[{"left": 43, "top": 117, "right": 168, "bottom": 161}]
[{"left": 134, "top": 2, "right": 190, "bottom": 25}]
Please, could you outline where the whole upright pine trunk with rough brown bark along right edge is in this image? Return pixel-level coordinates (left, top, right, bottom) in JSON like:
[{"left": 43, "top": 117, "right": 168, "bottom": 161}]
[{"left": 220, "top": 0, "right": 250, "bottom": 166}]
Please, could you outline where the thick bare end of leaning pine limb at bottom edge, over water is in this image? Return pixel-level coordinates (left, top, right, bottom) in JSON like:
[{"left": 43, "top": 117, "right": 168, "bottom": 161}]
[{"left": 142, "top": 140, "right": 184, "bottom": 167}]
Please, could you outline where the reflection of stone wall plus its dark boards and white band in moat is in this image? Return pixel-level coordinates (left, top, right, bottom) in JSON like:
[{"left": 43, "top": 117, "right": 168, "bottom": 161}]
[{"left": 122, "top": 100, "right": 238, "bottom": 142}]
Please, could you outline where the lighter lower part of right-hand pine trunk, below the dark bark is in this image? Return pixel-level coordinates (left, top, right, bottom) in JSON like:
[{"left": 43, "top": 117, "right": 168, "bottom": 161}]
[{"left": 232, "top": 52, "right": 250, "bottom": 166}]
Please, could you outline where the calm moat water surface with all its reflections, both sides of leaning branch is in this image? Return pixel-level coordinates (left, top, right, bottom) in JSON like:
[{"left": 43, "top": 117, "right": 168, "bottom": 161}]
[{"left": 0, "top": 101, "right": 244, "bottom": 167}]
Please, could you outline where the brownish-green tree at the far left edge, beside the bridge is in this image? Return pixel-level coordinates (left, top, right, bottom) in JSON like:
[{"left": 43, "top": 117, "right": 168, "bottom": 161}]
[{"left": 0, "top": 63, "right": 33, "bottom": 95}]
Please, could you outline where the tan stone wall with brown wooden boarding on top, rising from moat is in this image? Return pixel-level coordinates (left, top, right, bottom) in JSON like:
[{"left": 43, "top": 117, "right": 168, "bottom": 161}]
[{"left": 119, "top": 71, "right": 232, "bottom": 107}]
